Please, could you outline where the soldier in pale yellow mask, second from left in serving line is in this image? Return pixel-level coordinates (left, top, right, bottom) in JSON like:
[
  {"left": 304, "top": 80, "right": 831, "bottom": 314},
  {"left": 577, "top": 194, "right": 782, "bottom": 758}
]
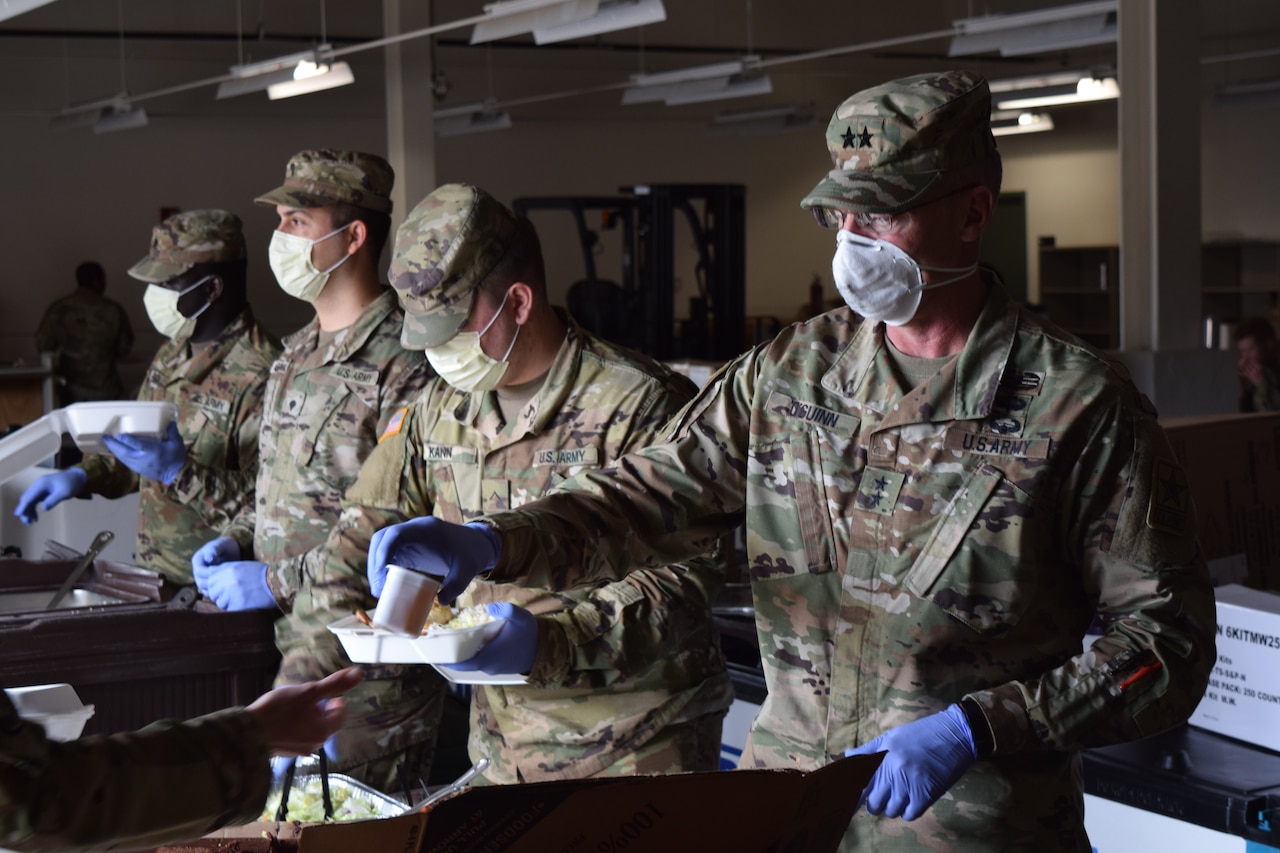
[{"left": 192, "top": 150, "right": 442, "bottom": 790}]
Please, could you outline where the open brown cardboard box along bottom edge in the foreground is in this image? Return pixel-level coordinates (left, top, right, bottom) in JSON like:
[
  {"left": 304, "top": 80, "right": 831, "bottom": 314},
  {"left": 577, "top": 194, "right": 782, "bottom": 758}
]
[{"left": 194, "top": 754, "right": 882, "bottom": 853}]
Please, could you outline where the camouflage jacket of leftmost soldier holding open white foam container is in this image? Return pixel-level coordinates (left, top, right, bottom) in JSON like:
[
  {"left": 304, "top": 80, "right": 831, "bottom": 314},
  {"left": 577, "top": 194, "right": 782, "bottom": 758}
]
[{"left": 81, "top": 309, "right": 280, "bottom": 583}]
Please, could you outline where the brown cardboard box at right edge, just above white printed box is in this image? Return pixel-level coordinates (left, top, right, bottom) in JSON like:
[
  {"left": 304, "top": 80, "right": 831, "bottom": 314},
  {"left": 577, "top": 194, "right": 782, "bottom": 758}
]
[{"left": 1161, "top": 414, "right": 1280, "bottom": 589}]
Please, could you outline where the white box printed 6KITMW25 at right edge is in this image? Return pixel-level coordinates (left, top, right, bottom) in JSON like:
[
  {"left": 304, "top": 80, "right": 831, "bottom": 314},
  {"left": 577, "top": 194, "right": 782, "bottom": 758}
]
[{"left": 1188, "top": 584, "right": 1280, "bottom": 751}]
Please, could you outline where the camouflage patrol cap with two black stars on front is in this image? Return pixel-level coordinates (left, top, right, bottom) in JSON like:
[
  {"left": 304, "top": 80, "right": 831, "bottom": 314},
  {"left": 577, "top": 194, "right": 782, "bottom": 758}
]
[{"left": 800, "top": 70, "right": 996, "bottom": 213}]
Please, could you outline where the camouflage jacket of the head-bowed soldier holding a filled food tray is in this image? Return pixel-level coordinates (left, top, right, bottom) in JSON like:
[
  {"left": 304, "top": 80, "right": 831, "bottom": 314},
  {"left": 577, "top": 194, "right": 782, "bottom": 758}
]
[{"left": 284, "top": 311, "right": 732, "bottom": 784}]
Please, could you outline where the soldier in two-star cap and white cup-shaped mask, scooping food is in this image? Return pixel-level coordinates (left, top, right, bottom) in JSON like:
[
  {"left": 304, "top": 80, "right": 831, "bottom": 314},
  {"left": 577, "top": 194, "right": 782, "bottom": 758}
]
[{"left": 369, "top": 72, "right": 1215, "bottom": 853}]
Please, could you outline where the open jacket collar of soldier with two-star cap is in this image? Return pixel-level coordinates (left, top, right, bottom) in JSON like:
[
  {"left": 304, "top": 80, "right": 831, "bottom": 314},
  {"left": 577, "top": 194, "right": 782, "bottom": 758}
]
[{"left": 822, "top": 273, "right": 1018, "bottom": 421}]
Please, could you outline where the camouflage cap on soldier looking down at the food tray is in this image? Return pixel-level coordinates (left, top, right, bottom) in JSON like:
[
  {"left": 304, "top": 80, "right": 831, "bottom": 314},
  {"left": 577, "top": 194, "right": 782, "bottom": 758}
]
[{"left": 388, "top": 183, "right": 516, "bottom": 350}]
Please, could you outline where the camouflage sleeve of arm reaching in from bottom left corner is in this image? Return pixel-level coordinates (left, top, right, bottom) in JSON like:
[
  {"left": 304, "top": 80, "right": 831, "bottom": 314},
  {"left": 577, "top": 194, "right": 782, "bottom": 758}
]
[{"left": 0, "top": 692, "right": 271, "bottom": 852}]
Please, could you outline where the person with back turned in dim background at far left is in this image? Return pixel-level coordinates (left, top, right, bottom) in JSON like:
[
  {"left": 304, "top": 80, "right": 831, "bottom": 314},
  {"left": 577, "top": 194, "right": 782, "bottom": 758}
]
[{"left": 36, "top": 261, "right": 133, "bottom": 406}]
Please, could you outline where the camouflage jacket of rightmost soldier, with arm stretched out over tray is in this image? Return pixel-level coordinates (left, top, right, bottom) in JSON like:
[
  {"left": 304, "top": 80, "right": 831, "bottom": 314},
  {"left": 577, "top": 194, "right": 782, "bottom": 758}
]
[{"left": 478, "top": 286, "right": 1215, "bottom": 852}]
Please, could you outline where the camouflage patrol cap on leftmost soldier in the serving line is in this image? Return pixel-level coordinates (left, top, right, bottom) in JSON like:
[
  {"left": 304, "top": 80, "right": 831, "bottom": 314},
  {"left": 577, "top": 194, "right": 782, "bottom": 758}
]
[{"left": 129, "top": 210, "right": 246, "bottom": 282}]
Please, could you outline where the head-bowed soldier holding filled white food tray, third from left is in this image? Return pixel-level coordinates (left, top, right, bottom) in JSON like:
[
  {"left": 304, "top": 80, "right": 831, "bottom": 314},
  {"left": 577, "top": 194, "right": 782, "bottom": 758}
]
[{"left": 282, "top": 184, "right": 733, "bottom": 784}]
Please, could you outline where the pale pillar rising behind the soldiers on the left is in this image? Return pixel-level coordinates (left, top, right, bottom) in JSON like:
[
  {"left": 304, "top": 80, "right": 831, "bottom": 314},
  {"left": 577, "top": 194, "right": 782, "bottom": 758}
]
[{"left": 383, "top": 0, "right": 435, "bottom": 229}]
